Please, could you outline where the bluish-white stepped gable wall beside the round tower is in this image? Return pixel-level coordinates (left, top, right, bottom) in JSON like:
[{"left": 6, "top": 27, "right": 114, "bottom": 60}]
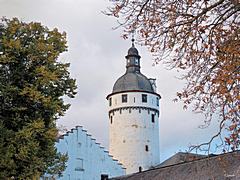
[{"left": 56, "top": 126, "right": 125, "bottom": 180}]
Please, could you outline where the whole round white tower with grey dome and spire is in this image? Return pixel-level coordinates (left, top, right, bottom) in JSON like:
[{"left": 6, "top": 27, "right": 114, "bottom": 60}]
[{"left": 107, "top": 40, "right": 160, "bottom": 174}]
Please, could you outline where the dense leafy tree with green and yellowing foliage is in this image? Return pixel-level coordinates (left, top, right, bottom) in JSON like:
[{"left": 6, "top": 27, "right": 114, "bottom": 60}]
[{"left": 0, "top": 18, "right": 76, "bottom": 179}]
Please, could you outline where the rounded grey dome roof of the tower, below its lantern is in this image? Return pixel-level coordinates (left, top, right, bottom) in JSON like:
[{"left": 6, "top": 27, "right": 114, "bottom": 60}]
[{"left": 113, "top": 72, "right": 154, "bottom": 93}]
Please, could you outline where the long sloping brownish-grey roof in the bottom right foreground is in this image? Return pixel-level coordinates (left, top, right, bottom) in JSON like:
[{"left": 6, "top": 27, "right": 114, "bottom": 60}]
[{"left": 113, "top": 151, "right": 240, "bottom": 180}]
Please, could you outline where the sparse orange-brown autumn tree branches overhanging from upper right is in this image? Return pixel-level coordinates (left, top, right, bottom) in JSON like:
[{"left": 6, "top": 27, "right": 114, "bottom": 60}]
[{"left": 105, "top": 0, "right": 240, "bottom": 150}]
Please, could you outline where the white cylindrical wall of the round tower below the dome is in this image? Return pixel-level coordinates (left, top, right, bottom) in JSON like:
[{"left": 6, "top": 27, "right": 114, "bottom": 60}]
[{"left": 108, "top": 92, "right": 160, "bottom": 174}]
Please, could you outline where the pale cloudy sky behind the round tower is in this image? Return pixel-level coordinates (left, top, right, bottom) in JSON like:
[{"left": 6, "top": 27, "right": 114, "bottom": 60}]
[{"left": 0, "top": 0, "right": 221, "bottom": 161}]
